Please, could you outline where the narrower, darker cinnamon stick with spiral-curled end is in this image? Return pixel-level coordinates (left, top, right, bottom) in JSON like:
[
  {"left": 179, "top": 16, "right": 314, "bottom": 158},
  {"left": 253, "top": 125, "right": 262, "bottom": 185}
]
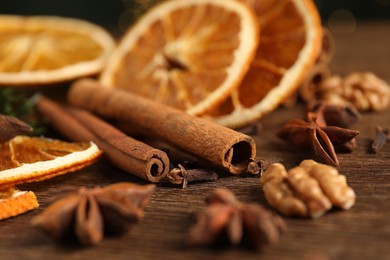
[{"left": 36, "top": 97, "right": 169, "bottom": 182}]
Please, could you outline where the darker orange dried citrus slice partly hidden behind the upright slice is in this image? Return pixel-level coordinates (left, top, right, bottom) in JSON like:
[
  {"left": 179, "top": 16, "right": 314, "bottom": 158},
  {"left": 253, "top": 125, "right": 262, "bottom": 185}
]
[{"left": 206, "top": 0, "right": 322, "bottom": 128}]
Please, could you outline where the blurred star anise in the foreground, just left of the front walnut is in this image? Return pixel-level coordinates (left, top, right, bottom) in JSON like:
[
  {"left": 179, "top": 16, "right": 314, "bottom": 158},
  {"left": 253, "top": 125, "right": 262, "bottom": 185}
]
[{"left": 189, "top": 188, "right": 286, "bottom": 249}]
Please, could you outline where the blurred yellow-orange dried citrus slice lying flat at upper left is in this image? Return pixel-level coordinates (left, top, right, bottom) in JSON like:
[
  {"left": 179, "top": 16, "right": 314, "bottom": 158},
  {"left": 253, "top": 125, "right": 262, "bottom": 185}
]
[{"left": 0, "top": 15, "right": 115, "bottom": 85}]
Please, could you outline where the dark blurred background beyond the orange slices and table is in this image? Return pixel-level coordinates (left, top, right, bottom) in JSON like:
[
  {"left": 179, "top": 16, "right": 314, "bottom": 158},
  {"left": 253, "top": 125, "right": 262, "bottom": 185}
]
[{"left": 0, "top": 0, "right": 390, "bottom": 32}]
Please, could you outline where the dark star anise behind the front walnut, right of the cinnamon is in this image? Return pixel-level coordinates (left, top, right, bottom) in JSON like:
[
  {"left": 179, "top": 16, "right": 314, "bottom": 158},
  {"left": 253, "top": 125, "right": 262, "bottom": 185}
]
[{"left": 277, "top": 112, "right": 359, "bottom": 166}]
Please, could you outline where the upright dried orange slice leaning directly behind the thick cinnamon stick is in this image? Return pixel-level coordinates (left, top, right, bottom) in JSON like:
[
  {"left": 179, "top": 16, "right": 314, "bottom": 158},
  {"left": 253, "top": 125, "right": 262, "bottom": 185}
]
[{"left": 100, "top": 0, "right": 259, "bottom": 114}]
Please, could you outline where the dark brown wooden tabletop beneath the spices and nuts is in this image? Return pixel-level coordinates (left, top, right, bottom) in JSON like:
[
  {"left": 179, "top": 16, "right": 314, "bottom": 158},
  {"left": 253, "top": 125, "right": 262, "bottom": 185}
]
[{"left": 0, "top": 21, "right": 390, "bottom": 259}]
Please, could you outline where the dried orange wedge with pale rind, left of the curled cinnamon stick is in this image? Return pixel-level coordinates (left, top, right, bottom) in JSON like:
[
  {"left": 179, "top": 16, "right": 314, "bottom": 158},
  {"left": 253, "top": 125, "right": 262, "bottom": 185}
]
[{"left": 0, "top": 136, "right": 101, "bottom": 188}]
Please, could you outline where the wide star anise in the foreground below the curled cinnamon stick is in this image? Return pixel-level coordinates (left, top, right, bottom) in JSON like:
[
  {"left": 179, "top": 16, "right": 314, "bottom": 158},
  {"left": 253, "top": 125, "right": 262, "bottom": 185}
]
[{"left": 31, "top": 183, "right": 155, "bottom": 245}]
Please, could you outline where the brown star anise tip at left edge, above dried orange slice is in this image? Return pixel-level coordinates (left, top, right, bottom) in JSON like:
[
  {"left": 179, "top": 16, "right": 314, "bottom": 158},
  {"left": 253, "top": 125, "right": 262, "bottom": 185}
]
[{"left": 0, "top": 114, "right": 33, "bottom": 143}]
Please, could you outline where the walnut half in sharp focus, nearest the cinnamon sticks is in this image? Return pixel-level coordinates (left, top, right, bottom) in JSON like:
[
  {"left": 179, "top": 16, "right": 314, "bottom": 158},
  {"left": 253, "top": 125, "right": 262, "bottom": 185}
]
[{"left": 260, "top": 160, "right": 356, "bottom": 218}]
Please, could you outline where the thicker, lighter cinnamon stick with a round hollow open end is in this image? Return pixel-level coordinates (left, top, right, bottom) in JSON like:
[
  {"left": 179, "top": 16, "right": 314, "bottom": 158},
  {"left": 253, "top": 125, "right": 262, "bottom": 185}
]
[{"left": 68, "top": 79, "right": 256, "bottom": 174}]
